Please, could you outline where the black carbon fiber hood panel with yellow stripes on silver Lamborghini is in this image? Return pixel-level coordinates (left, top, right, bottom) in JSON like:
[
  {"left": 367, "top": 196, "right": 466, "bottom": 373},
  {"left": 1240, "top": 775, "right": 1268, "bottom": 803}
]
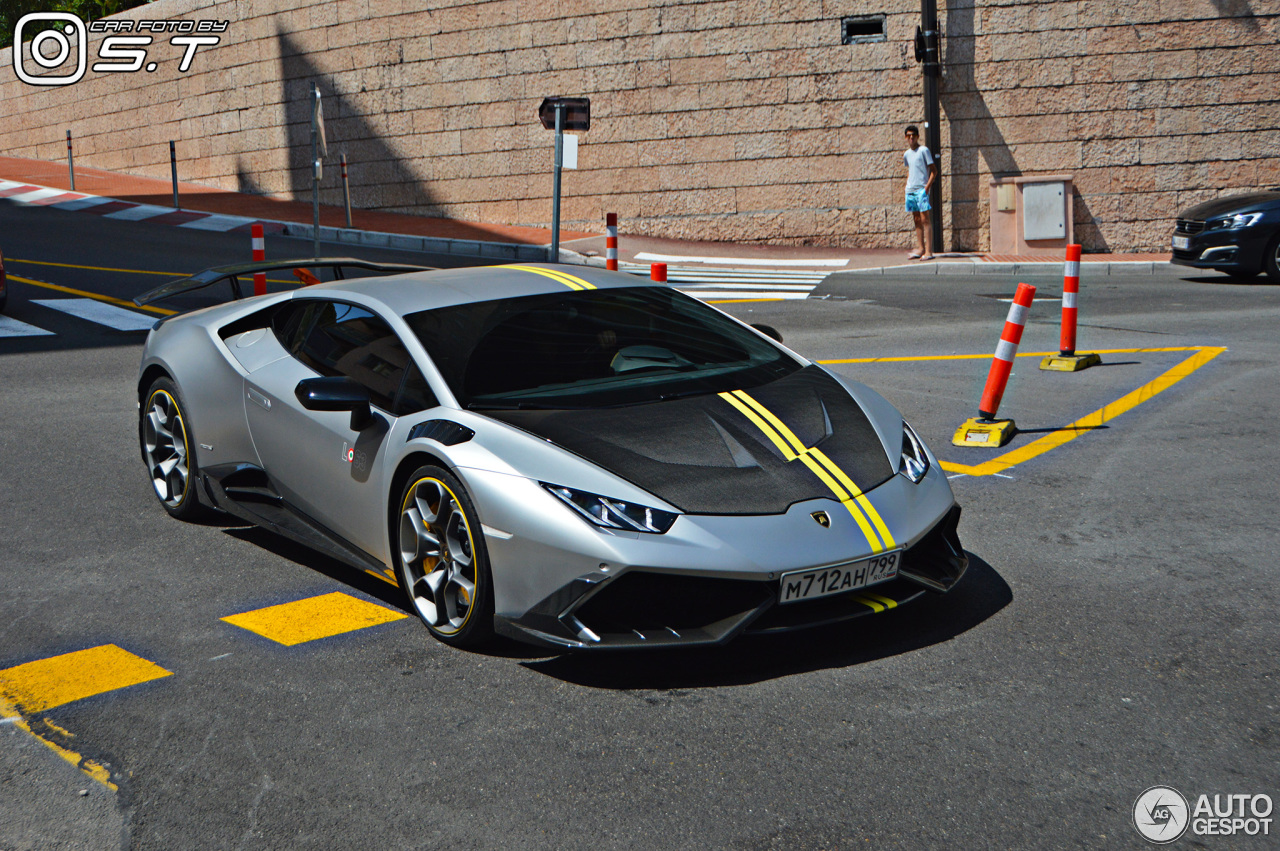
[{"left": 485, "top": 366, "right": 895, "bottom": 514}]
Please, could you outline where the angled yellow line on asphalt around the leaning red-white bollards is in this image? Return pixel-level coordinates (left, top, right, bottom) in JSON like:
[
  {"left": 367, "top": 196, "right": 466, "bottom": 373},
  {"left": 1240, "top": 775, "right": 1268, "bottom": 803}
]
[{"left": 818, "top": 346, "right": 1226, "bottom": 476}]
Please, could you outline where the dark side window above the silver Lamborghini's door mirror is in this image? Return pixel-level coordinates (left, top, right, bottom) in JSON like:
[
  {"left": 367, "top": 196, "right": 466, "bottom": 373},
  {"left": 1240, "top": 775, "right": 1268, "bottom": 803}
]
[{"left": 290, "top": 299, "right": 412, "bottom": 411}]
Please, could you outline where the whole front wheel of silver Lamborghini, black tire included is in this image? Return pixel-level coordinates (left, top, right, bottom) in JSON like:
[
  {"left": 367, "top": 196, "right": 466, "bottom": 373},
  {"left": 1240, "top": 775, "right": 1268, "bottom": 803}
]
[{"left": 394, "top": 466, "right": 493, "bottom": 648}]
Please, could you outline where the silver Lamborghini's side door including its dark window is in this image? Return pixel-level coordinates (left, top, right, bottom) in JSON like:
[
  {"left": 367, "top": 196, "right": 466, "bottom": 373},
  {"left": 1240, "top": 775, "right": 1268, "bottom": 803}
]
[{"left": 244, "top": 298, "right": 435, "bottom": 555}]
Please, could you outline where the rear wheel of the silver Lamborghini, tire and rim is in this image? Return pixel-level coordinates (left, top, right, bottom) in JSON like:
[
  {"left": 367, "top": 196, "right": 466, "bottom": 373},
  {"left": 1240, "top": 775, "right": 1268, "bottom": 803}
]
[{"left": 138, "top": 378, "right": 205, "bottom": 521}]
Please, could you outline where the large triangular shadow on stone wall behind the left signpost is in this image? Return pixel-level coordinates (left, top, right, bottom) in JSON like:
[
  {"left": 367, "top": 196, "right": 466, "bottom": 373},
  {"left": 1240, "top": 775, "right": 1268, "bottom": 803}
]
[{"left": 257, "top": 29, "right": 435, "bottom": 212}]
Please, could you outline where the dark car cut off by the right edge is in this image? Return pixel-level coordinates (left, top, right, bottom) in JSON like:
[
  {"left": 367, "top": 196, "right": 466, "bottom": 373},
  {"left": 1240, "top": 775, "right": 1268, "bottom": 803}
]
[{"left": 1174, "top": 187, "right": 1280, "bottom": 280}]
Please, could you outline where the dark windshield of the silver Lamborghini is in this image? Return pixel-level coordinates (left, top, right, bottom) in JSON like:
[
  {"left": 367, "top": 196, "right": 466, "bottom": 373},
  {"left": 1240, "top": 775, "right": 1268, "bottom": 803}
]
[{"left": 404, "top": 287, "right": 800, "bottom": 410}]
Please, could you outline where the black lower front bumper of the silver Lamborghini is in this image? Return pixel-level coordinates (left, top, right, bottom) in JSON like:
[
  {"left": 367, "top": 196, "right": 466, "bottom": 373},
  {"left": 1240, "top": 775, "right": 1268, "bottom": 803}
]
[{"left": 494, "top": 504, "right": 969, "bottom": 650}]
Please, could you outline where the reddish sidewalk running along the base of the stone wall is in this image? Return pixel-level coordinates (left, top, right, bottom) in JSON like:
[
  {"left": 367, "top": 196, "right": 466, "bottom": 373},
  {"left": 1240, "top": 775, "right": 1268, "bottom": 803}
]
[{"left": 0, "top": 156, "right": 1170, "bottom": 268}]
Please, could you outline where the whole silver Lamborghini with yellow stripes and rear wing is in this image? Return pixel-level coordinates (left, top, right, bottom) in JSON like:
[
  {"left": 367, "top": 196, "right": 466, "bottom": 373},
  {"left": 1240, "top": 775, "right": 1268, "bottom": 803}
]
[{"left": 137, "top": 260, "right": 968, "bottom": 650}]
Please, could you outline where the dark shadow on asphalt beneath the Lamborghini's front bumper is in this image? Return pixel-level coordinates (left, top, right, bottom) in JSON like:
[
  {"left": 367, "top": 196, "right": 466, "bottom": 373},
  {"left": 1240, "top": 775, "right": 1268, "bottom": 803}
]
[{"left": 521, "top": 553, "right": 1014, "bottom": 690}]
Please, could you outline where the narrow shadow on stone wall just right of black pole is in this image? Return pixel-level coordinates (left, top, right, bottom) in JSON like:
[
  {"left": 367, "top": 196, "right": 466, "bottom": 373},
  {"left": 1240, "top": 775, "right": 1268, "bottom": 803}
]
[{"left": 938, "top": 0, "right": 1023, "bottom": 250}]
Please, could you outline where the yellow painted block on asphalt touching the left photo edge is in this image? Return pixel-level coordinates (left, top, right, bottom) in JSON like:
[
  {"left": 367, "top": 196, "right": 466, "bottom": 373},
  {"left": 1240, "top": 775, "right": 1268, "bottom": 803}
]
[{"left": 0, "top": 644, "right": 170, "bottom": 714}]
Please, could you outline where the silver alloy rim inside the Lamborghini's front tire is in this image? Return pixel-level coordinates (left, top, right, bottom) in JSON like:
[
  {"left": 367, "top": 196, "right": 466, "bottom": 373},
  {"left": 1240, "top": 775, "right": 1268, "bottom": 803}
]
[{"left": 399, "top": 479, "right": 476, "bottom": 635}]
